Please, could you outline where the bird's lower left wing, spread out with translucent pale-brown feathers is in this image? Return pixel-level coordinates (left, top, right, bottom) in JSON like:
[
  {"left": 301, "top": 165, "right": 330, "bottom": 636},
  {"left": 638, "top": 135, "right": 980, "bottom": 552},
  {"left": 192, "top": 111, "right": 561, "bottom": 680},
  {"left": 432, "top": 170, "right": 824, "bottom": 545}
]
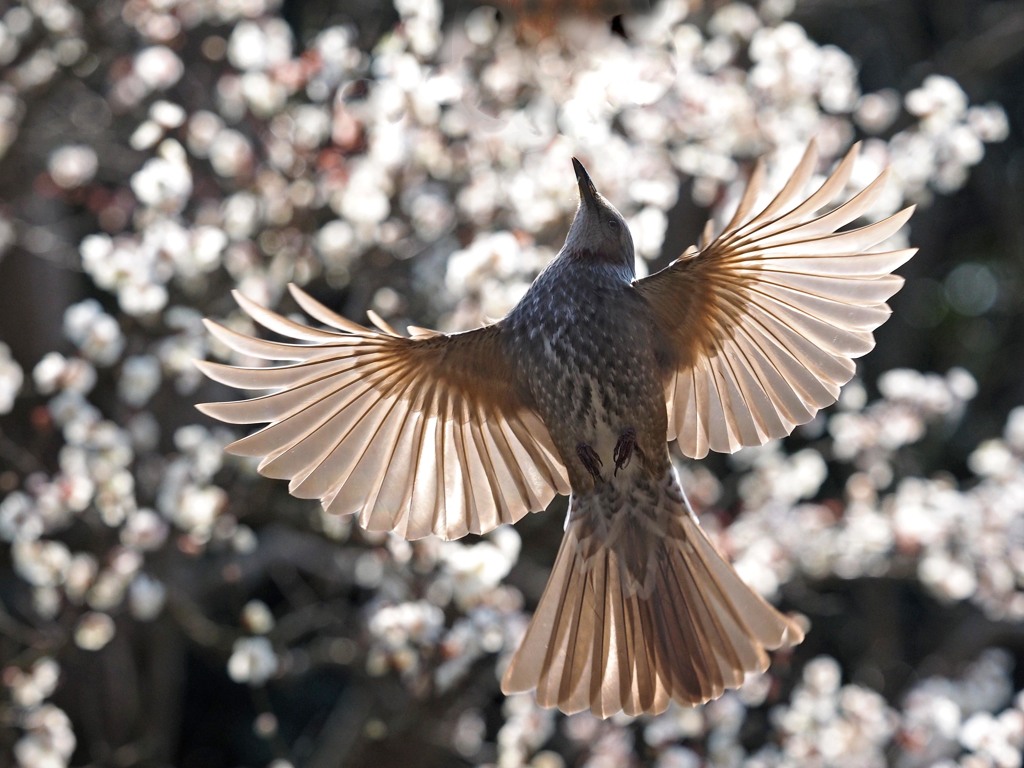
[{"left": 197, "top": 286, "right": 569, "bottom": 539}]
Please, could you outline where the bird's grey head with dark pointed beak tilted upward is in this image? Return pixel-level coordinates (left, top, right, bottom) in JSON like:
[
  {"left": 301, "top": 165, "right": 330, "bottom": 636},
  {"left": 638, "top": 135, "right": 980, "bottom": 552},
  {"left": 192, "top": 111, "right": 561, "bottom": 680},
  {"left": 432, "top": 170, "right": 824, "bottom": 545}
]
[{"left": 562, "top": 158, "right": 636, "bottom": 280}]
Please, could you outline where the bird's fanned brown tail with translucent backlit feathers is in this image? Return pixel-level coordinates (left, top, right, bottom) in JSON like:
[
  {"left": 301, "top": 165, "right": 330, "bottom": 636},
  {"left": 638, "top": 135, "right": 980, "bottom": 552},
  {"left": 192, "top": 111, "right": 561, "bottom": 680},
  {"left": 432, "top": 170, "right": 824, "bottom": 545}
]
[{"left": 502, "top": 472, "right": 804, "bottom": 718}]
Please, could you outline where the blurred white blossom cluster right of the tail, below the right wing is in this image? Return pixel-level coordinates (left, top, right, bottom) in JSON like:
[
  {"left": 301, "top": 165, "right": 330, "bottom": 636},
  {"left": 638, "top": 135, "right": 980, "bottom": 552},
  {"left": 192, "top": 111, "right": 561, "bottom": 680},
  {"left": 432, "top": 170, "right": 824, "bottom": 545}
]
[{"left": 727, "top": 369, "right": 1024, "bottom": 621}]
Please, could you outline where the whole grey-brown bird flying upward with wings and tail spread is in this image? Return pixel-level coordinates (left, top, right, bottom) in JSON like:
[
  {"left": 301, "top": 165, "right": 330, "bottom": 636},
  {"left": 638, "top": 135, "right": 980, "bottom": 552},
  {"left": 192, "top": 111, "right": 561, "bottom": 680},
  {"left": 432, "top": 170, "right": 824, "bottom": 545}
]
[{"left": 197, "top": 141, "right": 915, "bottom": 718}]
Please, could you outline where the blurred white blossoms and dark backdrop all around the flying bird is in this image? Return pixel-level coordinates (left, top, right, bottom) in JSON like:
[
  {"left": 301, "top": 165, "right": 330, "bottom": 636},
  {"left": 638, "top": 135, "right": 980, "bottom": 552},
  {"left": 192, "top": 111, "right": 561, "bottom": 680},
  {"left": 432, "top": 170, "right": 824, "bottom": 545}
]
[{"left": 0, "top": 0, "right": 1024, "bottom": 768}]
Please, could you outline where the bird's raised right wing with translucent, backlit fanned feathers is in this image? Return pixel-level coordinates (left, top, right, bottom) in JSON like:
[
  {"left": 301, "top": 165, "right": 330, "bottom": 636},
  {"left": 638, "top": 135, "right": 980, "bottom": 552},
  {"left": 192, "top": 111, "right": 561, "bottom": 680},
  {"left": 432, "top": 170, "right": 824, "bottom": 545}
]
[{"left": 635, "top": 143, "right": 915, "bottom": 458}]
